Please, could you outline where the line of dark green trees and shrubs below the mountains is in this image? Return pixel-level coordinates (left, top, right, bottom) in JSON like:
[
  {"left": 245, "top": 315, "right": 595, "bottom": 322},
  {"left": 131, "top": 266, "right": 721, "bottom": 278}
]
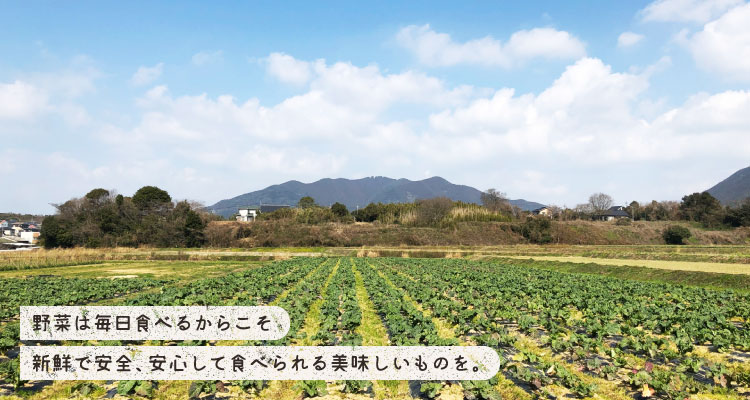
[{"left": 40, "top": 186, "right": 750, "bottom": 248}]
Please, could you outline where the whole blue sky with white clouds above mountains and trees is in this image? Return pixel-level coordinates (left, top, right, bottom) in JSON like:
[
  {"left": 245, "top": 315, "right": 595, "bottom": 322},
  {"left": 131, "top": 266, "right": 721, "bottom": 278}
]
[{"left": 0, "top": 0, "right": 750, "bottom": 213}]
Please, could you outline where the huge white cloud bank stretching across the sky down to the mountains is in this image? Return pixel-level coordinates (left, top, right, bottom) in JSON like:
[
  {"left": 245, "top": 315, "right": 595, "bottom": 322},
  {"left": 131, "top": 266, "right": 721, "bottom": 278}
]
[{"left": 3, "top": 55, "right": 750, "bottom": 212}]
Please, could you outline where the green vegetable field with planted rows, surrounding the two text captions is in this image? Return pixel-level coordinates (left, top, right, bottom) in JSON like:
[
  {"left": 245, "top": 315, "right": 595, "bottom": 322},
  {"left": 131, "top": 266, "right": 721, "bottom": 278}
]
[{"left": 0, "top": 252, "right": 750, "bottom": 399}]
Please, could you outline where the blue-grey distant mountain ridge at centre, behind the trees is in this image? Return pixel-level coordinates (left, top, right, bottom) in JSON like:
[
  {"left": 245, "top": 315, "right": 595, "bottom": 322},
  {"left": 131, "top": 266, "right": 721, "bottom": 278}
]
[{"left": 206, "top": 176, "right": 543, "bottom": 217}]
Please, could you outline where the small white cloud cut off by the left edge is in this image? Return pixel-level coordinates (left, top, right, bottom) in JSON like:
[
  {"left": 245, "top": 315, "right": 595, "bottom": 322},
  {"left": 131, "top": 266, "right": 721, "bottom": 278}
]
[{"left": 0, "top": 80, "right": 47, "bottom": 120}]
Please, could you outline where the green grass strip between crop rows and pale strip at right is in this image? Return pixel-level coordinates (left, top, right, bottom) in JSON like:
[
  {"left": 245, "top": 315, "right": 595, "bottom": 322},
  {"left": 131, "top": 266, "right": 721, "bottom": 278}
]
[{"left": 497, "top": 258, "right": 750, "bottom": 291}]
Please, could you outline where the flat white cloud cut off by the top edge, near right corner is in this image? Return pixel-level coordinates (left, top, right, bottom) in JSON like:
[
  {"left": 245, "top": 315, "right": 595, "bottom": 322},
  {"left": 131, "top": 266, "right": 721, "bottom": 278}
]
[{"left": 641, "top": 0, "right": 742, "bottom": 23}]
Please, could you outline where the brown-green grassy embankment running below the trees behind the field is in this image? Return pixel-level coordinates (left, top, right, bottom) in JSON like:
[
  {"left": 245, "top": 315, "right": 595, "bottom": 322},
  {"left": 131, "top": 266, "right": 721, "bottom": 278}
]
[{"left": 206, "top": 220, "right": 750, "bottom": 248}]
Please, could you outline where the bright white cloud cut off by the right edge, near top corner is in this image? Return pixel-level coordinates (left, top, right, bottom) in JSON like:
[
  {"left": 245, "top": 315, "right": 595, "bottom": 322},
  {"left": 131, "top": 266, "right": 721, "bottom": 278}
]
[{"left": 682, "top": 4, "right": 750, "bottom": 82}]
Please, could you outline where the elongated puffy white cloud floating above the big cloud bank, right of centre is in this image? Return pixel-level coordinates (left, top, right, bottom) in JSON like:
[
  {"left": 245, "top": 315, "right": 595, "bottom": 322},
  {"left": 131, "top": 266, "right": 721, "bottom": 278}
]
[{"left": 396, "top": 25, "right": 586, "bottom": 68}]
